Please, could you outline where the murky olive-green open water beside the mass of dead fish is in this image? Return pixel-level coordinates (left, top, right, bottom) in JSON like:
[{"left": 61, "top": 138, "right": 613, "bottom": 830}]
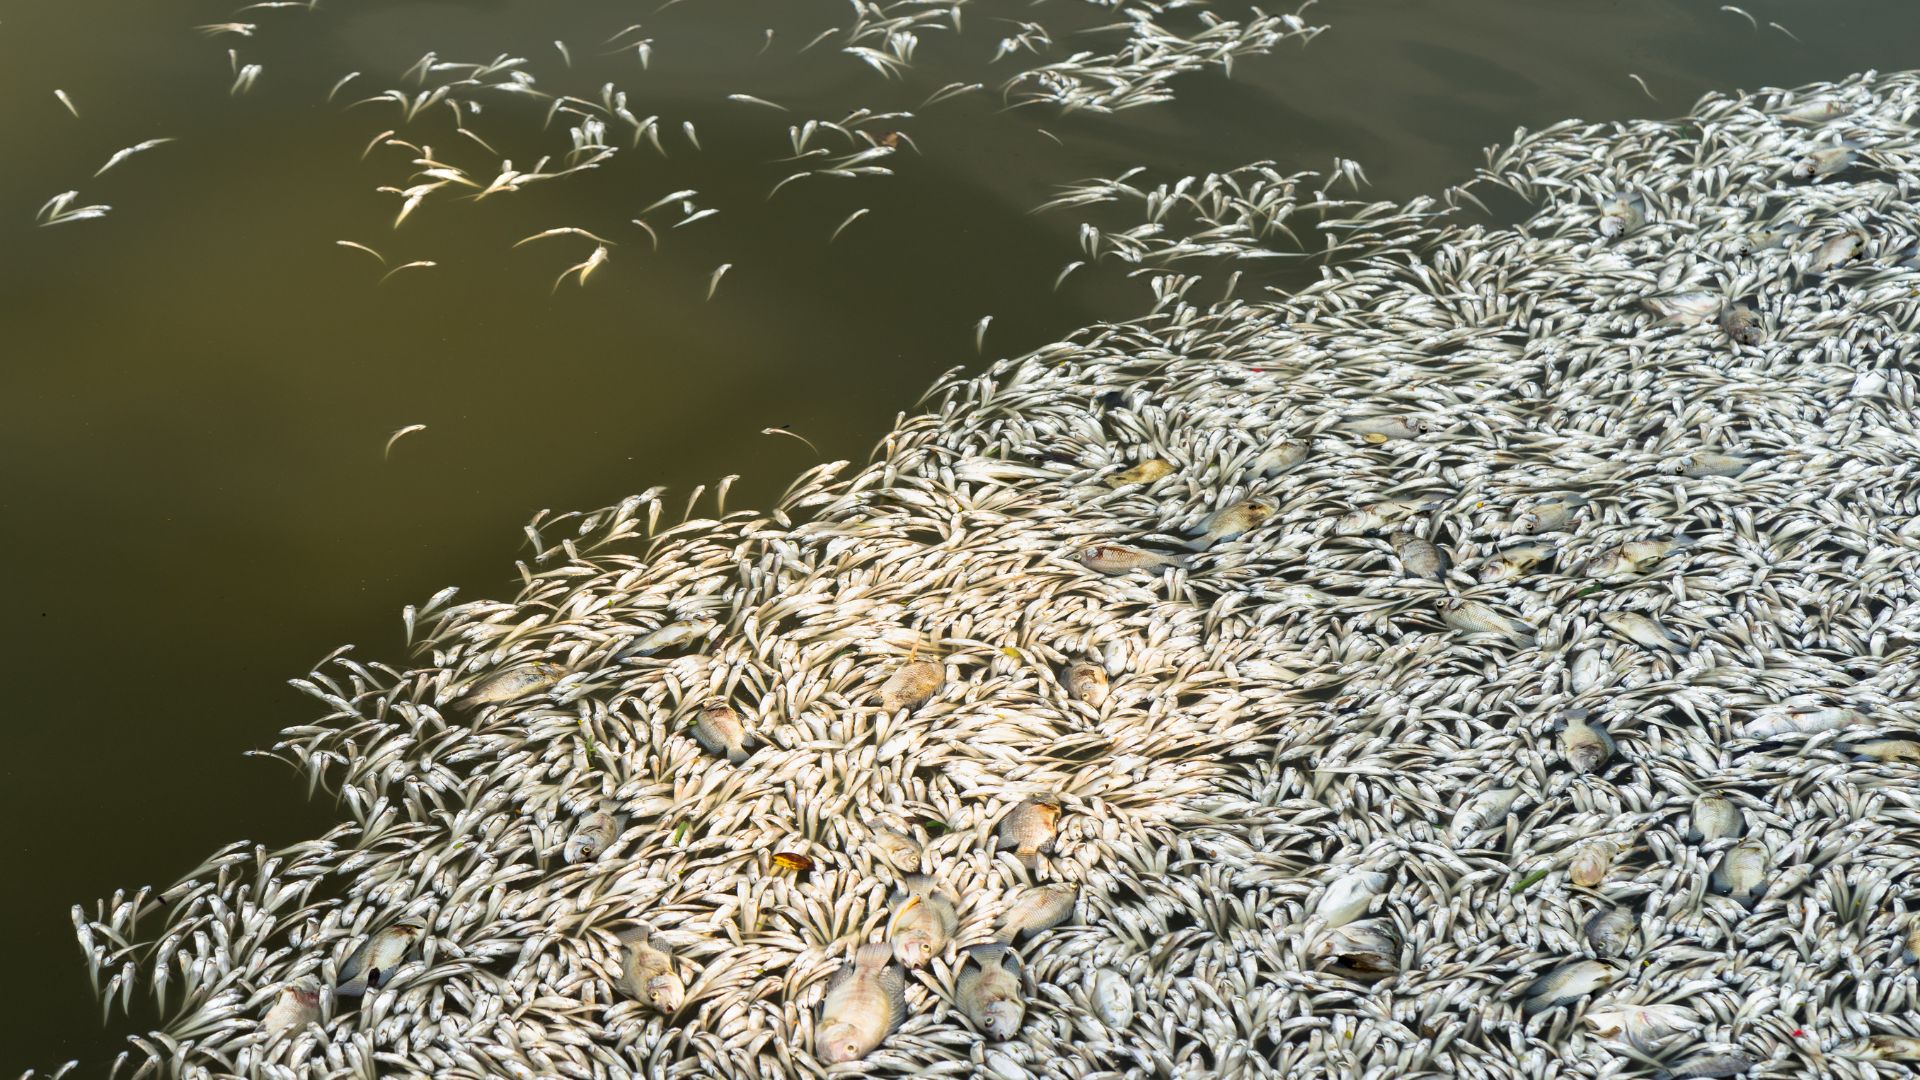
[{"left": 0, "top": 0, "right": 1920, "bottom": 1072}]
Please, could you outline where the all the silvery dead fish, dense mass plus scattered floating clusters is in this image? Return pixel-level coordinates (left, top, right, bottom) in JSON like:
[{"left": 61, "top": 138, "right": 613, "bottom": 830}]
[{"left": 30, "top": 2, "right": 1920, "bottom": 1078}]
